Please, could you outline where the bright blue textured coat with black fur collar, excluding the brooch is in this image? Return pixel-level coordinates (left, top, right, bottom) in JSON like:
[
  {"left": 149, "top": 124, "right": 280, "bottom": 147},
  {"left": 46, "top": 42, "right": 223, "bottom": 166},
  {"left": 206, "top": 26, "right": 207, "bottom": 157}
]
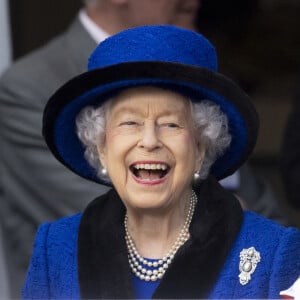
[{"left": 23, "top": 181, "right": 300, "bottom": 299}]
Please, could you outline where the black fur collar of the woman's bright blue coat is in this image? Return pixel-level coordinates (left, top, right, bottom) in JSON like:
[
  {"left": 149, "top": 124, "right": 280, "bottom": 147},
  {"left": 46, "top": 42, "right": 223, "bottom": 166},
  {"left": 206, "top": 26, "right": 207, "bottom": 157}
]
[{"left": 78, "top": 178, "right": 242, "bottom": 299}]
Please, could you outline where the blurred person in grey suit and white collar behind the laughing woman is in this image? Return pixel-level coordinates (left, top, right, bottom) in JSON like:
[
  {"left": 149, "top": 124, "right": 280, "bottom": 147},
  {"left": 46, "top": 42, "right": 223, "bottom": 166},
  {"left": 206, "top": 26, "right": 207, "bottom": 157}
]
[{"left": 0, "top": 0, "right": 200, "bottom": 298}]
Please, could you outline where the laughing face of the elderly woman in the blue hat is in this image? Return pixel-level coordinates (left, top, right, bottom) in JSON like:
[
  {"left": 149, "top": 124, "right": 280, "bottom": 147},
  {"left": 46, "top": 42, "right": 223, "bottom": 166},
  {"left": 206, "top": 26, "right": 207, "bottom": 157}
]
[{"left": 98, "top": 87, "right": 203, "bottom": 213}]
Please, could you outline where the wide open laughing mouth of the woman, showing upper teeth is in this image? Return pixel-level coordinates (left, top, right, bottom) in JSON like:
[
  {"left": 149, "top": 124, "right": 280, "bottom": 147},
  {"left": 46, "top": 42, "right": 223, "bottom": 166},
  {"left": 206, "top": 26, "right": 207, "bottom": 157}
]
[{"left": 130, "top": 163, "right": 170, "bottom": 181}]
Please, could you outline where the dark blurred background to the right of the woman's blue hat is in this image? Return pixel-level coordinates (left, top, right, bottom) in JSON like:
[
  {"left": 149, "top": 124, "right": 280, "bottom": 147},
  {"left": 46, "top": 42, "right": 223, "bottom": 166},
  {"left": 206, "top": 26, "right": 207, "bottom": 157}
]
[{"left": 198, "top": 0, "right": 300, "bottom": 227}]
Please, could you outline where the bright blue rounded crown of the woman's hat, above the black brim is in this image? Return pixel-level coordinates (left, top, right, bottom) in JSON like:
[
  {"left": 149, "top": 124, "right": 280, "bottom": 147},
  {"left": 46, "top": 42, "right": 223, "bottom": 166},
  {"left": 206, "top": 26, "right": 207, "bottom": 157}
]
[{"left": 88, "top": 25, "right": 217, "bottom": 71}]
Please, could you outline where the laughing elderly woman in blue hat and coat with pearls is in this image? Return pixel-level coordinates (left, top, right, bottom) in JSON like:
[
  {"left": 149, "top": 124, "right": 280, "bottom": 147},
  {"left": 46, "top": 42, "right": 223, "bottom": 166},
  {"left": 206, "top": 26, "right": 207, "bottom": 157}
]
[{"left": 23, "top": 26, "right": 300, "bottom": 299}]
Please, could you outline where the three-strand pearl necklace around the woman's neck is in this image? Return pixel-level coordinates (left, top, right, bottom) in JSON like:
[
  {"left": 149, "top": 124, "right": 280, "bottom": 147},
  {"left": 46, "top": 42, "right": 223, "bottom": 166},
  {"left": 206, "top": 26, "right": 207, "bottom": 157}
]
[{"left": 124, "top": 191, "right": 197, "bottom": 281}]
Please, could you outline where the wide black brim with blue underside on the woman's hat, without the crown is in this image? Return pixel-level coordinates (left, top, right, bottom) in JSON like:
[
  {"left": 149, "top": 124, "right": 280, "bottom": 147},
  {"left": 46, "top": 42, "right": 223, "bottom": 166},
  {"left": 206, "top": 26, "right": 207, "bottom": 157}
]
[{"left": 43, "top": 61, "right": 259, "bottom": 184}]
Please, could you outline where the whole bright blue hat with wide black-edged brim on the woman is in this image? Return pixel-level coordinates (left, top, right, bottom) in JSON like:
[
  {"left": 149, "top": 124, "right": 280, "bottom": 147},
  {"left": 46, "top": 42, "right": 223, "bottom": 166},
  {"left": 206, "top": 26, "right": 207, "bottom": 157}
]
[{"left": 43, "top": 25, "right": 258, "bottom": 184}]
